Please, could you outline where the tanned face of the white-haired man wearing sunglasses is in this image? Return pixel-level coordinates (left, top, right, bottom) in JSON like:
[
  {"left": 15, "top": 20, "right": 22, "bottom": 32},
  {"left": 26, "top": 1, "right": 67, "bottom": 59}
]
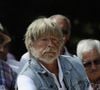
[{"left": 83, "top": 49, "right": 100, "bottom": 83}]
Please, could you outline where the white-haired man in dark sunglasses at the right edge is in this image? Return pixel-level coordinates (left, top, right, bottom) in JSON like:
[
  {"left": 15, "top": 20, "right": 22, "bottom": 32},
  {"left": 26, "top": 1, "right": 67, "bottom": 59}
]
[{"left": 77, "top": 39, "right": 100, "bottom": 90}]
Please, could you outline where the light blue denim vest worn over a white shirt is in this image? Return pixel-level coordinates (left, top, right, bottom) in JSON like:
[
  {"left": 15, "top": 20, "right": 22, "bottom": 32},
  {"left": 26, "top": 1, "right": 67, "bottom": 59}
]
[{"left": 20, "top": 55, "right": 89, "bottom": 90}]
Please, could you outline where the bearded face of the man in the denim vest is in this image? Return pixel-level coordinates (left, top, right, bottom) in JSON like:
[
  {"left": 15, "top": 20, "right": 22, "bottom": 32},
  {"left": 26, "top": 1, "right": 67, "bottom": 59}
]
[{"left": 31, "top": 35, "right": 61, "bottom": 63}]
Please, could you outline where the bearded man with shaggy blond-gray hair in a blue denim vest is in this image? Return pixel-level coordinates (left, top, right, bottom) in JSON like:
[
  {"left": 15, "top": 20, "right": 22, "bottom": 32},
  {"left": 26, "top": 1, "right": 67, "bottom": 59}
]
[{"left": 16, "top": 18, "right": 90, "bottom": 90}]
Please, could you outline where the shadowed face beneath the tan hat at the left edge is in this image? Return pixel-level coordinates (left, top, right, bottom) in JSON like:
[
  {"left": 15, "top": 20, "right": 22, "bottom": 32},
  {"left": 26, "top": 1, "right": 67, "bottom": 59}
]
[{"left": 0, "top": 44, "right": 8, "bottom": 60}]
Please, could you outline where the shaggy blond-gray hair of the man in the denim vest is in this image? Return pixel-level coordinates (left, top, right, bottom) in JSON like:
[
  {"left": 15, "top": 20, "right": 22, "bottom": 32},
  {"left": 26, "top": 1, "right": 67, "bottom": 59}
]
[{"left": 25, "top": 18, "right": 63, "bottom": 52}]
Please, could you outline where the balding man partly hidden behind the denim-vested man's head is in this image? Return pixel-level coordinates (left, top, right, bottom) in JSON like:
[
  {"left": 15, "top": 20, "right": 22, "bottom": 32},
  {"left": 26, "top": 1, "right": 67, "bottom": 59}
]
[{"left": 49, "top": 14, "right": 72, "bottom": 55}]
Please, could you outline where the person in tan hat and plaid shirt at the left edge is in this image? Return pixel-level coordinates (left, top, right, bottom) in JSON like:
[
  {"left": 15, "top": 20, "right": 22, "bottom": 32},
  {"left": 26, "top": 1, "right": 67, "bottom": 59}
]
[{"left": 0, "top": 24, "right": 17, "bottom": 90}]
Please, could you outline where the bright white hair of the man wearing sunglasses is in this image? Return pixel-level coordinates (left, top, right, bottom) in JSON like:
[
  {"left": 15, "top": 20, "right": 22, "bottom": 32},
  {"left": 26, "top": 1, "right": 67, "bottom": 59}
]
[{"left": 76, "top": 39, "right": 100, "bottom": 60}]
